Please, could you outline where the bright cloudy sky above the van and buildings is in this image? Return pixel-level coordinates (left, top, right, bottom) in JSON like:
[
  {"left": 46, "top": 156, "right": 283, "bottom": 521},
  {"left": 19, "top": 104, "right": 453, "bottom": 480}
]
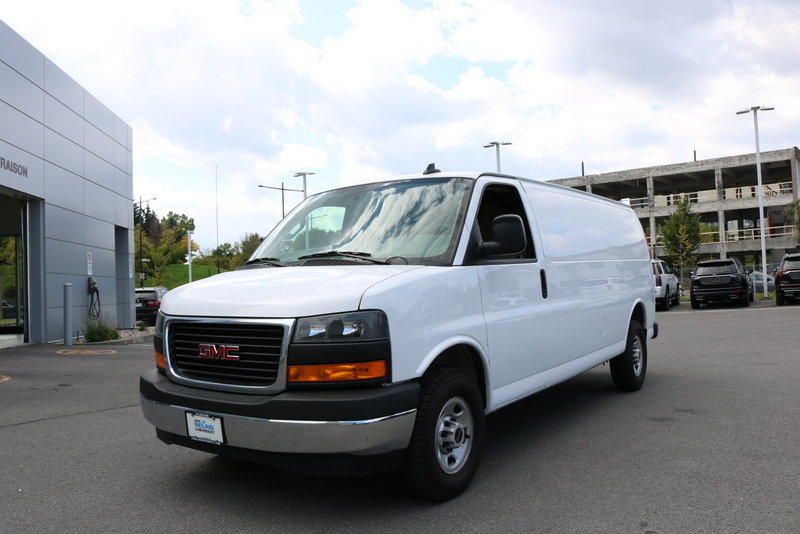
[{"left": 0, "top": 0, "right": 800, "bottom": 249}]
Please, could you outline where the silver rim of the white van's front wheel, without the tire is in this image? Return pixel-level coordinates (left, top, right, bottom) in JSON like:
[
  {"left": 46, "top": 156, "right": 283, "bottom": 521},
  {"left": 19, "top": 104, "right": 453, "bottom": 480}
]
[{"left": 435, "top": 397, "right": 474, "bottom": 475}]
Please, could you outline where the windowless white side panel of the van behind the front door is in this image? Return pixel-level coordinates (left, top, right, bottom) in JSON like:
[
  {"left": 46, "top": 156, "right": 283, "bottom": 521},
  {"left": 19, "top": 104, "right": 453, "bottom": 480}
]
[{"left": 525, "top": 182, "right": 653, "bottom": 367}]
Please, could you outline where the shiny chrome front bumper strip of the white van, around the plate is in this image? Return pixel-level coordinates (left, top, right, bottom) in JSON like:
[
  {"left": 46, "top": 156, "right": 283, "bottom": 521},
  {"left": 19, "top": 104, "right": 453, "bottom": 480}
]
[{"left": 141, "top": 396, "right": 417, "bottom": 455}]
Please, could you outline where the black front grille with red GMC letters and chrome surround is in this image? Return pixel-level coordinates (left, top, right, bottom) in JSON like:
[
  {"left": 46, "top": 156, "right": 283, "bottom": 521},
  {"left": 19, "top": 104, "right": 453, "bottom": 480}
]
[{"left": 168, "top": 322, "right": 284, "bottom": 387}]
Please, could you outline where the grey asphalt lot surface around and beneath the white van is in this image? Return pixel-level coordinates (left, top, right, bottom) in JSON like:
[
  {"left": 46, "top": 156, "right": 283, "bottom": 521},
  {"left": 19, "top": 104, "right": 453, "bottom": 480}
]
[{"left": 0, "top": 301, "right": 800, "bottom": 534}]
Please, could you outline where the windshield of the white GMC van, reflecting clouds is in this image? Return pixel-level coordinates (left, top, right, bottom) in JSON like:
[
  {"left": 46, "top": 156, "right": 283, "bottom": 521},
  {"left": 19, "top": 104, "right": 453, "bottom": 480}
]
[{"left": 251, "top": 178, "right": 473, "bottom": 265}]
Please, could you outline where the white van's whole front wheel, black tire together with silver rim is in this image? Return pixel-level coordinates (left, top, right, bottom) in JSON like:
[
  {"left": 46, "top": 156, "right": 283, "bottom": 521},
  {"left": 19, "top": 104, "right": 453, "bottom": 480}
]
[{"left": 401, "top": 367, "right": 484, "bottom": 501}]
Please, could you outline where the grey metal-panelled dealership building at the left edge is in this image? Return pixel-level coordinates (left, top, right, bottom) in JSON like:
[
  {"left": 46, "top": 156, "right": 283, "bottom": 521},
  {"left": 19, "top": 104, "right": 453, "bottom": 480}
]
[{"left": 0, "top": 21, "right": 135, "bottom": 347}]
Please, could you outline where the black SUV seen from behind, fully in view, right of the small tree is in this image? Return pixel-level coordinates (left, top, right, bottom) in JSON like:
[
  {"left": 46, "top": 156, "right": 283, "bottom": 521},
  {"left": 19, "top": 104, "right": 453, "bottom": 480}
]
[{"left": 691, "top": 258, "right": 755, "bottom": 309}]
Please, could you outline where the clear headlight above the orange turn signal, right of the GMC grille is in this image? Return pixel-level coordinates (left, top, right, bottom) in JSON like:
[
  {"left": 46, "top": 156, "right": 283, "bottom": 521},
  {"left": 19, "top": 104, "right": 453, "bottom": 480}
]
[{"left": 293, "top": 311, "right": 389, "bottom": 343}]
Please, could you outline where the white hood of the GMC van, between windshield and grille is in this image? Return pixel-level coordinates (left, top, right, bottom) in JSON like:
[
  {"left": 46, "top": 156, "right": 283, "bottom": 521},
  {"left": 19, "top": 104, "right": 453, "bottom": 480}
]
[{"left": 161, "top": 265, "right": 423, "bottom": 319}]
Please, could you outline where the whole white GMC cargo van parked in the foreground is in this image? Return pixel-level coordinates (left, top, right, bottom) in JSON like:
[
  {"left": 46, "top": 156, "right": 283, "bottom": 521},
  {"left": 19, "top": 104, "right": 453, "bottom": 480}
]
[{"left": 140, "top": 172, "right": 658, "bottom": 500}]
